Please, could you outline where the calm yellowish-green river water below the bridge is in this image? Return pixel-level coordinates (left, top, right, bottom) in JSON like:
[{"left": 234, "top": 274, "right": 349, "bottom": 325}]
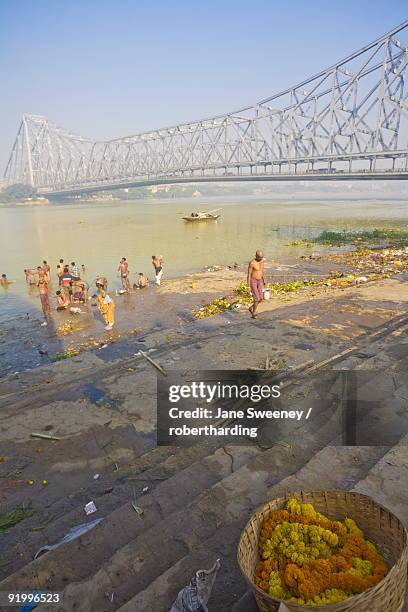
[{"left": 0, "top": 198, "right": 408, "bottom": 323}]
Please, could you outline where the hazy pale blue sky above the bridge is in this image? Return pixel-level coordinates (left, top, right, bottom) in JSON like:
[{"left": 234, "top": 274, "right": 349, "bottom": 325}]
[{"left": 0, "top": 0, "right": 408, "bottom": 172}]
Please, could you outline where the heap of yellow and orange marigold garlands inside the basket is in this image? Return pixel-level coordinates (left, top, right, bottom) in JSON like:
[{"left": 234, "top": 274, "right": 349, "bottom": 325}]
[{"left": 255, "top": 498, "right": 388, "bottom": 605}]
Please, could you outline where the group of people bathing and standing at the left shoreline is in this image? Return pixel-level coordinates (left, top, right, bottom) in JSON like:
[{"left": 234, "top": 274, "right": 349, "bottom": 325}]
[{"left": 20, "top": 255, "right": 163, "bottom": 331}]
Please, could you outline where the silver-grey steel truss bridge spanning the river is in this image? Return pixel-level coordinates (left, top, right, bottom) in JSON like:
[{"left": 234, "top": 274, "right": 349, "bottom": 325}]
[{"left": 4, "top": 20, "right": 408, "bottom": 196}]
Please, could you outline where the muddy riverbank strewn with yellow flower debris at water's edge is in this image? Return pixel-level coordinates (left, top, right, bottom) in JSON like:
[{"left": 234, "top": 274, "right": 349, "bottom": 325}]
[{"left": 0, "top": 241, "right": 408, "bottom": 375}]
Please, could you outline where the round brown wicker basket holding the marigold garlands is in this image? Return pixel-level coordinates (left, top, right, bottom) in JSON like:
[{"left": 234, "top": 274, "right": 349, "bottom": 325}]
[{"left": 238, "top": 491, "right": 408, "bottom": 612}]
